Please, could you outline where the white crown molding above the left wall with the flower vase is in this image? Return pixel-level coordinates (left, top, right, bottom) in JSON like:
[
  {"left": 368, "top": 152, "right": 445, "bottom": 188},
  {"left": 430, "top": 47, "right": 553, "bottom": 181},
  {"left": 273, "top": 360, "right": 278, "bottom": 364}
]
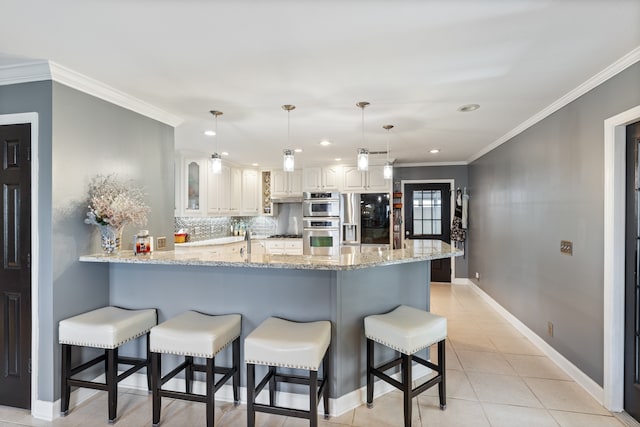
[{"left": 0, "top": 61, "right": 184, "bottom": 127}]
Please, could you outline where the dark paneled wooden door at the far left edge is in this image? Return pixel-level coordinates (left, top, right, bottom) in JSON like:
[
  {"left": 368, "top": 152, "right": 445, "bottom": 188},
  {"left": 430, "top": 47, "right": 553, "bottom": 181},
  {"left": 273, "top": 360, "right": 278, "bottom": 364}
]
[{"left": 0, "top": 124, "right": 31, "bottom": 409}]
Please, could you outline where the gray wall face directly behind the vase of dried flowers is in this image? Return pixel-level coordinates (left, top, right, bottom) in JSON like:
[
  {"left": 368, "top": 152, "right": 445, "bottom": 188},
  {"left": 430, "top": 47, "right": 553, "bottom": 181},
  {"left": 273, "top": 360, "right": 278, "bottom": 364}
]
[{"left": 48, "top": 83, "right": 174, "bottom": 400}]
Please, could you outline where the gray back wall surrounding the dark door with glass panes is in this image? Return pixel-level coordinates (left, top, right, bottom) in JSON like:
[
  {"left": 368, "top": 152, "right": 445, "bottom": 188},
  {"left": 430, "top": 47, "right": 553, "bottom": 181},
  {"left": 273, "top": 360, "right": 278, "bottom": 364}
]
[{"left": 393, "top": 165, "right": 475, "bottom": 278}]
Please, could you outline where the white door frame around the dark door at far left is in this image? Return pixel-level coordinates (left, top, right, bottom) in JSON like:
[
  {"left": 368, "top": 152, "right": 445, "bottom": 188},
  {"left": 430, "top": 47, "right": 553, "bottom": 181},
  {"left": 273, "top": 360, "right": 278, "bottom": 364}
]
[{"left": 0, "top": 112, "right": 40, "bottom": 413}]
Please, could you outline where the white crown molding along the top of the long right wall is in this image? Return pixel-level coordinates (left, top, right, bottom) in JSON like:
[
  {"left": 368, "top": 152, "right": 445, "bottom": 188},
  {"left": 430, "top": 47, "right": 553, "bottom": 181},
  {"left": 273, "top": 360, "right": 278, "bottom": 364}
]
[{"left": 467, "top": 46, "right": 640, "bottom": 163}]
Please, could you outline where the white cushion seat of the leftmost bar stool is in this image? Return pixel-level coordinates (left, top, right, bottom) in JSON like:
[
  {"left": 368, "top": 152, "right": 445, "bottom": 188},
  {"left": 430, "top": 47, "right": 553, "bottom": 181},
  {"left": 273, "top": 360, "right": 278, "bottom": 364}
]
[{"left": 58, "top": 307, "right": 157, "bottom": 349}]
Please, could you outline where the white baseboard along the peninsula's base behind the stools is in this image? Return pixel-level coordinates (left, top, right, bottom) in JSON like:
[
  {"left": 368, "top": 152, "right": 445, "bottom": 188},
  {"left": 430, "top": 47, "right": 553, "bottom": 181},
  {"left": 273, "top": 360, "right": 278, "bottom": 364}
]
[{"left": 36, "top": 365, "right": 431, "bottom": 421}]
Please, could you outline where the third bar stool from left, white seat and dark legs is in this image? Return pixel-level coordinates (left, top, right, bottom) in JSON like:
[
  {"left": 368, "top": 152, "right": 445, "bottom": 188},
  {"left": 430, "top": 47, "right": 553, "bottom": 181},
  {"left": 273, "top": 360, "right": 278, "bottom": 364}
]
[{"left": 244, "top": 317, "right": 331, "bottom": 427}]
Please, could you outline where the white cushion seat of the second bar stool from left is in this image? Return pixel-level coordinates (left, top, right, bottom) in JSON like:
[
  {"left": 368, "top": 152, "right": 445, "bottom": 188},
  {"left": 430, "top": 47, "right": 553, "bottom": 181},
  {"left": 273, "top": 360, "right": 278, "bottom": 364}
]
[{"left": 151, "top": 311, "right": 242, "bottom": 358}]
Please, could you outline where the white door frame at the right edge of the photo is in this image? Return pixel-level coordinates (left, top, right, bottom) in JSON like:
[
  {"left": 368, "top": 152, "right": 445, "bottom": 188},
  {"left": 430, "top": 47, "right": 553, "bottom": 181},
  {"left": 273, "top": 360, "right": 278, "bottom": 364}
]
[{"left": 603, "top": 105, "right": 640, "bottom": 412}]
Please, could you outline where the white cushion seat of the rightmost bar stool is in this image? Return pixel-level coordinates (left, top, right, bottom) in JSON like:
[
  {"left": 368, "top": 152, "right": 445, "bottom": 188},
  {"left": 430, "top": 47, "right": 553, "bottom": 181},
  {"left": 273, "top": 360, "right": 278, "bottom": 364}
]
[{"left": 364, "top": 305, "right": 447, "bottom": 354}]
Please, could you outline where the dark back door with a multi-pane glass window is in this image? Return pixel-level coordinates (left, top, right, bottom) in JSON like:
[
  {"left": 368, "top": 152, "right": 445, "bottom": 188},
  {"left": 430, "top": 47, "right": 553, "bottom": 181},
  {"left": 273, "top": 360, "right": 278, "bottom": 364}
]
[{"left": 404, "top": 183, "right": 451, "bottom": 282}]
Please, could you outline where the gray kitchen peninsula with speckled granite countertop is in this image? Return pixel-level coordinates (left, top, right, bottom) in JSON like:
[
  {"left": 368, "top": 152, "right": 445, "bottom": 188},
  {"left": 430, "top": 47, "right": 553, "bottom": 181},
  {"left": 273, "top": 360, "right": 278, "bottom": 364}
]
[{"left": 80, "top": 240, "right": 462, "bottom": 413}]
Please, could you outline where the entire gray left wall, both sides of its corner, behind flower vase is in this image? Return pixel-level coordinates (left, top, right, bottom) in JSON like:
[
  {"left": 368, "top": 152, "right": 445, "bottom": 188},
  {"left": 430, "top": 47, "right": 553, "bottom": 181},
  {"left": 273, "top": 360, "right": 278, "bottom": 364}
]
[{"left": 0, "top": 81, "right": 174, "bottom": 401}]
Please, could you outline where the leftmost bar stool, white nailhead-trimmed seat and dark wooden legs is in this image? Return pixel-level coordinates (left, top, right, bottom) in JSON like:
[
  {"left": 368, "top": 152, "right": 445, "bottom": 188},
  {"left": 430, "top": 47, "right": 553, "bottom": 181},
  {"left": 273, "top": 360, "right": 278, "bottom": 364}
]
[{"left": 58, "top": 307, "right": 158, "bottom": 423}]
